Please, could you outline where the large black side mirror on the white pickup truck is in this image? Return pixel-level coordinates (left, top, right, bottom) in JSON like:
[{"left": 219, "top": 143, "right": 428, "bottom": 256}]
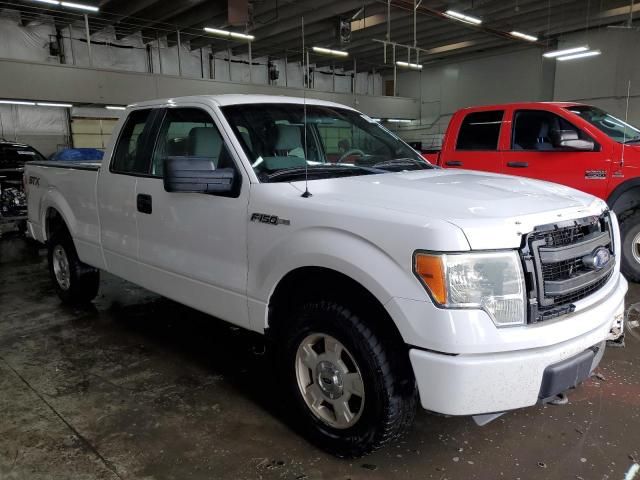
[{"left": 164, "top": 157, "right": 236, "bottom": 195}]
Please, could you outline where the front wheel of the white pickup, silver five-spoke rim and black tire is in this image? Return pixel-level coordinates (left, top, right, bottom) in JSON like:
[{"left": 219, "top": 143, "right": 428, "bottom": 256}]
[{"left": 280, "top": 301, "right": 417, "bottom": 457}]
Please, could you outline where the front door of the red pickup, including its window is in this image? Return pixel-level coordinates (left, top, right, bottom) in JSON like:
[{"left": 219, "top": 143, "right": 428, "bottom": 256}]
[{"left": 503, "top": 109, "right": 611, "bottom": 198}]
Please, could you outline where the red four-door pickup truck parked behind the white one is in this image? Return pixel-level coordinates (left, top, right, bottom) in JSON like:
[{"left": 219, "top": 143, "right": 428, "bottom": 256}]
[{"left": 438, "top": 102, "right": 640, "bottom": 282}]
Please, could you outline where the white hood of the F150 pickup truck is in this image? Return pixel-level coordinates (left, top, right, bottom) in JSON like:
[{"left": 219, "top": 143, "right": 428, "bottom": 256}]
[{"left": 293, "top": 169, "right": 606, "bottom": 250}]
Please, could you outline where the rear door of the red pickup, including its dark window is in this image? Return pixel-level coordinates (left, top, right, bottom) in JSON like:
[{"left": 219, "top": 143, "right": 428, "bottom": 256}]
[{"left": 440, "top": 109, "right": 504, "bottom": 172}]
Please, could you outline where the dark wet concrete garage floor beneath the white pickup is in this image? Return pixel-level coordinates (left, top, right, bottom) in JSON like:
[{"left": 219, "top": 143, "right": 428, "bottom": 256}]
[{"left": 0, "top": 236, "right": 640, "bottom": 480}]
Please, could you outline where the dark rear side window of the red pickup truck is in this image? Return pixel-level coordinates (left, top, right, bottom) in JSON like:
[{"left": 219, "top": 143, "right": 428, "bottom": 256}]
[{"left": 456, "top": 110, "right": 504, "bottom": 151}]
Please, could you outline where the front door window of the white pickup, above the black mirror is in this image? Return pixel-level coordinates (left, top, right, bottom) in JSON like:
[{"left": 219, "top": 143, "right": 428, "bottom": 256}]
[{"left": 151, "top": 108, "right": 233, "bottom": 177}]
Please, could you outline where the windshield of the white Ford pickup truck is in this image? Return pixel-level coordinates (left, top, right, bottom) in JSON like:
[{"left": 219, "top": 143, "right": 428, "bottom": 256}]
[{"left": 222, "top": 103, "right": 433, "bottom": 182}]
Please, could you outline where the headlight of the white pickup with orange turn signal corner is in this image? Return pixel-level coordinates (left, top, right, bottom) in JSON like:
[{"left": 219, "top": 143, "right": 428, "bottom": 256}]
[{"left": 414, "top": 250, "right": 526, "bottom": 326}]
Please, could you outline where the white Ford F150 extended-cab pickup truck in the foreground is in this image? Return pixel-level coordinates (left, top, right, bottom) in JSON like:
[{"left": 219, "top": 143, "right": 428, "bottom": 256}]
[{"left": 25, "top": 95, "right": 627, "bottom": 456}]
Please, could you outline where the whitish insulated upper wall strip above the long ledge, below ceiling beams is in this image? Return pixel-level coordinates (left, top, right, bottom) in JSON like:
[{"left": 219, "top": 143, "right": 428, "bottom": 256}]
[{"left": 0, "top": 9, "right": 382, "bottom": 95}]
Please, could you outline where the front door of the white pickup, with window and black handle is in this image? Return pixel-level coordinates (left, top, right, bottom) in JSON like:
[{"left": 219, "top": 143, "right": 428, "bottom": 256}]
[{"left": 136, "top": 105, "right": 249, "bottom": 327}]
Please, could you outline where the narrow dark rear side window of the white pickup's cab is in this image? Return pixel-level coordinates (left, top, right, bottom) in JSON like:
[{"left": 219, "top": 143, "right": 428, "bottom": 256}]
[{"left": 111, "top": 109, "right": 151, "bottom": 174}]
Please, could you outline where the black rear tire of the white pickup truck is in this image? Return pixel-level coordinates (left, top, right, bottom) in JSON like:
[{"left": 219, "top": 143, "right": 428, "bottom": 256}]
[{"left": 47, "top": 229, "right": 100, "bottom": 305}]
